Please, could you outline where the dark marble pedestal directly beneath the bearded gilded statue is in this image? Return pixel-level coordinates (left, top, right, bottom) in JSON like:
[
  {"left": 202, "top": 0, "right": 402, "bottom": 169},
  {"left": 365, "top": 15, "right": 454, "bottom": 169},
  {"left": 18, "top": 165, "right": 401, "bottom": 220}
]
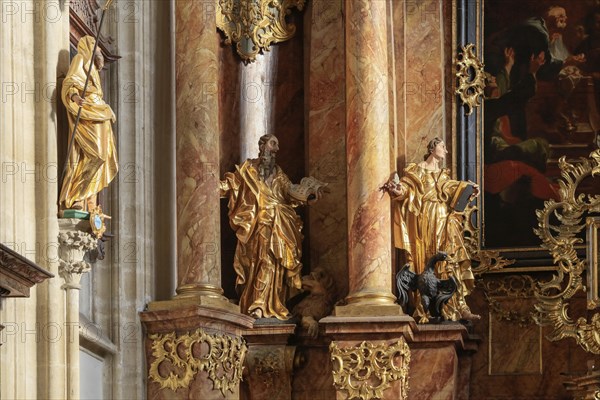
[{"left": 240, "top": 320, "right": 296, "bottom": 400}]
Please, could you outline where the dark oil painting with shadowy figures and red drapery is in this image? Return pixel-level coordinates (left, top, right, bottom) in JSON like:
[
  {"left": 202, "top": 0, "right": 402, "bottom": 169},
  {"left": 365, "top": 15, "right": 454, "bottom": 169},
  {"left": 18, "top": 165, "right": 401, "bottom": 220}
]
[{"left": 482, "top": 0, "right": 600, "bottom": 249}]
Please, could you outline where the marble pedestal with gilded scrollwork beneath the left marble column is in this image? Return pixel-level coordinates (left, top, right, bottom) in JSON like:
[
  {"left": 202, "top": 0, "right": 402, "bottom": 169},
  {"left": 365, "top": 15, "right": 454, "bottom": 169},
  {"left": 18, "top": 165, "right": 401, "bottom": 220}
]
[{"left": 140, "top": 304, "right": 254, "bottom": 400}]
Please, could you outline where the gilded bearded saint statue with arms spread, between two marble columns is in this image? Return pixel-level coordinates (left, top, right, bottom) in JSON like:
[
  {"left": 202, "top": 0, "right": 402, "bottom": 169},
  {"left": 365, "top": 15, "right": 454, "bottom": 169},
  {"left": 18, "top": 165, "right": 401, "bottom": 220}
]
[{"left": 220, "top": 134, "right": 326, "bottom": 320}]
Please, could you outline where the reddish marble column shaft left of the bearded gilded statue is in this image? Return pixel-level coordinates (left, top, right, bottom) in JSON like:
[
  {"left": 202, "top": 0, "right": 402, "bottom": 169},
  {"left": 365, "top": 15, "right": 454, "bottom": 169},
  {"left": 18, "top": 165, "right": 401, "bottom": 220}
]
[{"left": 175, "top": 0, "right": 222, "bottom": 297}]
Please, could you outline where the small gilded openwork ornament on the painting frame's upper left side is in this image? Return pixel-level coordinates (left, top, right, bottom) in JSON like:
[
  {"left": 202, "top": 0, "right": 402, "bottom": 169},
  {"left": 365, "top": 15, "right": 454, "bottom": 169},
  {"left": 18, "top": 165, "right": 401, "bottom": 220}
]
[{"left": 455, "top": 43, "right": 485, "bottom": 115}]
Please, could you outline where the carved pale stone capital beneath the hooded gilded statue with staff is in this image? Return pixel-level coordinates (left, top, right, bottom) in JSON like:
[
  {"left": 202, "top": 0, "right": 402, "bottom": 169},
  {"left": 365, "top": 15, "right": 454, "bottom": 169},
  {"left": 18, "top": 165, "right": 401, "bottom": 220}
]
[{"left": 58, "top": 220, "right": 98, "bottom": 289}]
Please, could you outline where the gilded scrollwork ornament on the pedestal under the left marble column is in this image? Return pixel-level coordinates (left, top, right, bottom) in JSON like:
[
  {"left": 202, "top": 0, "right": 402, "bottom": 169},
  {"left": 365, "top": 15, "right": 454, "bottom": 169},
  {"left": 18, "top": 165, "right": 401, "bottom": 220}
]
[{"left": 148, "top": 329, "right": 248, "bottom": 397}]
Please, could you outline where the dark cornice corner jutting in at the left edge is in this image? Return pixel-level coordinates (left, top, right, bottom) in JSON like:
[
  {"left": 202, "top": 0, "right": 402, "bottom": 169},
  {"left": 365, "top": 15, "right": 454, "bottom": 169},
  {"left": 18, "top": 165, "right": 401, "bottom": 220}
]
[{"left": 0, "top": 243, "right": 54, "bottom": 297}]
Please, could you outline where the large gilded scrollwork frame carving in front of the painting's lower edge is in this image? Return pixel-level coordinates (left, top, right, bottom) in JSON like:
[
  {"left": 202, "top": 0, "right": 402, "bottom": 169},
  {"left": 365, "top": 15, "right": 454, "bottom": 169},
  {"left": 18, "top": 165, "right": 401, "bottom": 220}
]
[{"left": 535, "top": 150, "right": 600, "bottom": 354}]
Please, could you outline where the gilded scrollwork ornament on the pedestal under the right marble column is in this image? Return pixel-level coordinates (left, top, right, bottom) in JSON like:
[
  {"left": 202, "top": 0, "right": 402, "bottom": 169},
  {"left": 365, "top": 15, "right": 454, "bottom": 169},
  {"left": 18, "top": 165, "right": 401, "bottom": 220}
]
[{"left": 329, "top": 338, "right": 410, "bottom": 400}]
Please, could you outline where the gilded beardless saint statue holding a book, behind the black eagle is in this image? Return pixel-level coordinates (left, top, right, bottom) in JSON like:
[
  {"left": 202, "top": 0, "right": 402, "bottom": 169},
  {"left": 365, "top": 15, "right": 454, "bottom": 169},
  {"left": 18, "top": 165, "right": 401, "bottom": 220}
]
[{"left": 384, "top": 138, "right": 479, "bottom": 323}]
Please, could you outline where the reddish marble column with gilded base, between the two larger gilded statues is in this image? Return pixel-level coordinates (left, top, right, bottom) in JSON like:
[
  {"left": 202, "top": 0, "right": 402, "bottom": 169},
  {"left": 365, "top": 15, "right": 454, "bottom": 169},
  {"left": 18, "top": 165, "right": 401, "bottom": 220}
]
[{"left": 335, "top": 0, "right": 402, "bottom": 316}]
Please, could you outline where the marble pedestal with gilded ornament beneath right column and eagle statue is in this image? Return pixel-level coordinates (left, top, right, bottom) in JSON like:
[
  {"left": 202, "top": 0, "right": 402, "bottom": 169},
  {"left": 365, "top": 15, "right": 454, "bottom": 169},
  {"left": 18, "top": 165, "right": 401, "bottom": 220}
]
[{"left": 320, "top": 316, "right": 478, "bottom": 400}]
